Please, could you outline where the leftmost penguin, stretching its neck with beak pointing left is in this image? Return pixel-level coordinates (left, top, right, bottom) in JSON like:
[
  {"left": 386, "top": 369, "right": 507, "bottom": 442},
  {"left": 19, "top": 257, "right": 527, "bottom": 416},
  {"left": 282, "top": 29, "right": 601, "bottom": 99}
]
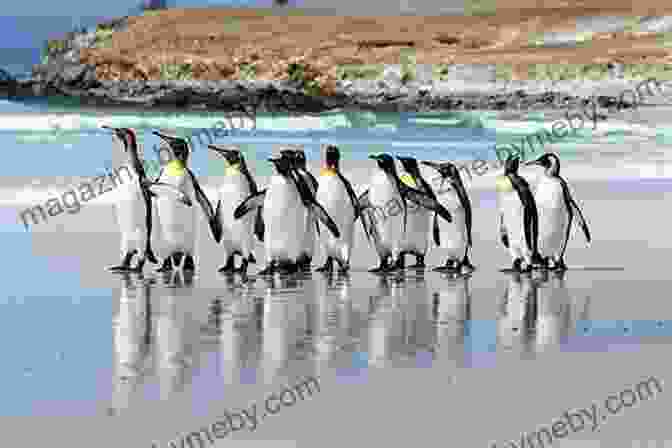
[{"left": 102, "top": 126, "right": 158, "bottom": 272}]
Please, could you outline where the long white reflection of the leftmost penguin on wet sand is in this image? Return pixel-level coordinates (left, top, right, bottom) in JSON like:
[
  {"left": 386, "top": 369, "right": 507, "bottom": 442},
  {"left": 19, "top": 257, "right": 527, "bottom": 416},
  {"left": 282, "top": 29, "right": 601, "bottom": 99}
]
[{"left": 110, "top": 273, "right": 152, "bottom": 414}]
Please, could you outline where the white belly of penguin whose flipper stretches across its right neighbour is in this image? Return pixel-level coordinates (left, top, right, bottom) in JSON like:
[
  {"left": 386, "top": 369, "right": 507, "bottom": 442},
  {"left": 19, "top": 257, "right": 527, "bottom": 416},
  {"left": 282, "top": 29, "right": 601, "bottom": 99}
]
[{"left": 369, "top": 171, "right": 404, "bottom": 256}]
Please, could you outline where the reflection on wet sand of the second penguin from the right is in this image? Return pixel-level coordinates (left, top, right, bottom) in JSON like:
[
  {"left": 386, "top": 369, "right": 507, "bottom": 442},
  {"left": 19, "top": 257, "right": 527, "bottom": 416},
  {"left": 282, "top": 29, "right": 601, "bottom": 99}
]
[{"left": 497, "top": 272, "right": 537, "bottom": 354}]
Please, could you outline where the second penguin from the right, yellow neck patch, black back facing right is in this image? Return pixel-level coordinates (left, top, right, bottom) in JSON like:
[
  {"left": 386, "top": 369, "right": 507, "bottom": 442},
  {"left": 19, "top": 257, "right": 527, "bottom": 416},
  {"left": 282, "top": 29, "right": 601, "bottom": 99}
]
[{"left": 496, "top": 156, "right": 543, "bottom": 272}]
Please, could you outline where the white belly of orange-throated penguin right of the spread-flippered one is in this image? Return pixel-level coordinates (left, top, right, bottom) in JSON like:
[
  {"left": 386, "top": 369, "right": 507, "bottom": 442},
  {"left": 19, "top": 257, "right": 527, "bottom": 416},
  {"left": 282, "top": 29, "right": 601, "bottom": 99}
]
[{"left": 317, "top": 175, "right": 355, "bottom": 262}]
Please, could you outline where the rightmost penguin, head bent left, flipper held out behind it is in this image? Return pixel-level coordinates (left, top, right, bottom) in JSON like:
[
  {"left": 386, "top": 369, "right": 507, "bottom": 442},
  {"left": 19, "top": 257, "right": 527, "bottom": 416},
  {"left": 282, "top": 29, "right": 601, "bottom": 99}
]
[{"left": 525, "top": 153, "right": 591, "bottom": 270}]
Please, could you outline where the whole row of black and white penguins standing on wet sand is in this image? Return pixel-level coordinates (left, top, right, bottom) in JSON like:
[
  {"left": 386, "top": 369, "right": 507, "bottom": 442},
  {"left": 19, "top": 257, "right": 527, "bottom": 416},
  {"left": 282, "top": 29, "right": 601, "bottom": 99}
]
[{"left": 104, "top": 127, "right": 591, "bottom": 275}]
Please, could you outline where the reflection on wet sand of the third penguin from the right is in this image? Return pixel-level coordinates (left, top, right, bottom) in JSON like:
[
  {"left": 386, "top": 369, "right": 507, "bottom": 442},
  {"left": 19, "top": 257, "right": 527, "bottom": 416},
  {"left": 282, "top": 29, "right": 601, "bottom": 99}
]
[{"left": 433, "top": 276, "right": 471, "bottom": 369}]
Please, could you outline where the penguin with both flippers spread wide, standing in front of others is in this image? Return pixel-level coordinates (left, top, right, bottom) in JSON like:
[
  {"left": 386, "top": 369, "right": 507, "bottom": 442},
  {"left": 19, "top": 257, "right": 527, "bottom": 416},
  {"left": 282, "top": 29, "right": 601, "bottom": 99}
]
[{"left": 233, "top": 155, "right": 340, "bottom": 275}]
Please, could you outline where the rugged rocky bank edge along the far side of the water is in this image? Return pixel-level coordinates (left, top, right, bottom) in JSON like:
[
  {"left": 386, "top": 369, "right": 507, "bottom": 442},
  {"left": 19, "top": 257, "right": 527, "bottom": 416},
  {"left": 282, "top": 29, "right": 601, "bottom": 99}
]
[{"left": 0, "top": 14, "right": 660, "bottom": 113}]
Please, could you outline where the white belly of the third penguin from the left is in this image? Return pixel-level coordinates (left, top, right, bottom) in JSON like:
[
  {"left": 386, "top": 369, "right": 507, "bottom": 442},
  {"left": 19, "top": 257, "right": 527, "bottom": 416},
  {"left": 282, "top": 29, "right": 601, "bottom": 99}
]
[{"left": 219, "top": 174, "right": 257, "bottom": 257}]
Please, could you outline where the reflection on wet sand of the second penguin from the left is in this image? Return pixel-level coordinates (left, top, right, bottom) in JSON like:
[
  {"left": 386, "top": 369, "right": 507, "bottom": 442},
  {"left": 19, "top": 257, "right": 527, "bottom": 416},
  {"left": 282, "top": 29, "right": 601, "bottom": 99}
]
[{"left": 155, "top": 271, "right": 198, "bottom": 400}]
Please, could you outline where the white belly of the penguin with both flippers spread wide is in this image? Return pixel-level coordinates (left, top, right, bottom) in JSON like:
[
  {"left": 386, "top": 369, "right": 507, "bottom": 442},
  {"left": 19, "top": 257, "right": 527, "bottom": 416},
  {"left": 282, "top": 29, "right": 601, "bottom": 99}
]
[{"left": 264, "top": 176, "right": 306, "bottom": 259}]
